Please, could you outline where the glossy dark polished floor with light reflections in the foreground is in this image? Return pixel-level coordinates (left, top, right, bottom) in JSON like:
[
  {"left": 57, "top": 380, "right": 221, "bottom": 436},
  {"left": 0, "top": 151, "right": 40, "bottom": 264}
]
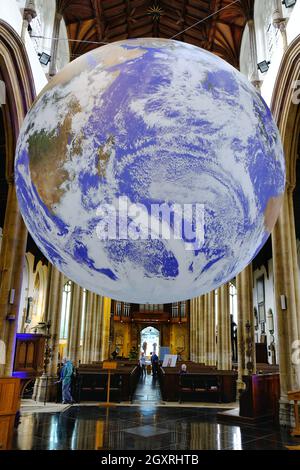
[{"left": 13, "top": 404, "right": 300, "bottom": 450}]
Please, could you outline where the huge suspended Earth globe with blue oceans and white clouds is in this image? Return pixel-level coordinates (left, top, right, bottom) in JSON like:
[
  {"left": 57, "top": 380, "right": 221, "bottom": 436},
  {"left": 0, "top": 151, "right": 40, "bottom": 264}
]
[{"left": 15, "top": 38, "right": 285, "bottom": 303}]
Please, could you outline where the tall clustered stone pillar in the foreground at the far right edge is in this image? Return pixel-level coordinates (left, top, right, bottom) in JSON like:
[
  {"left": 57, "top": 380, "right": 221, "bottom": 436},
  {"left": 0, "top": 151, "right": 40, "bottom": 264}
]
[{"left": 272, "top": 186, "right": 300, "bottom": 425}]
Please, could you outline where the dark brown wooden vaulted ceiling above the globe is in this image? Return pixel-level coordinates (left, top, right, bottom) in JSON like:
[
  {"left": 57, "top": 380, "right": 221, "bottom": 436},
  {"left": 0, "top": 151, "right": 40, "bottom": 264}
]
[{"left": 57, "top": 0, "right": 254, "bottom": 68}]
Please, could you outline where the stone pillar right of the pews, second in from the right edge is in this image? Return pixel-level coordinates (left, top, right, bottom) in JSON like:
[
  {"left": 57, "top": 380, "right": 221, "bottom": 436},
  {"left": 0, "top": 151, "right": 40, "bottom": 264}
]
[{"left": 236, "top": 263, "right": 256, "bottom": 391}]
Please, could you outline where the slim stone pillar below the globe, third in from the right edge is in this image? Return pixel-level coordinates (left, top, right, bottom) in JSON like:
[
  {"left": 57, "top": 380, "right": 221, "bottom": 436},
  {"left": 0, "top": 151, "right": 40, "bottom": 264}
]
[{"left": 217, "top": 284, "right": 232, "bottom": 370}]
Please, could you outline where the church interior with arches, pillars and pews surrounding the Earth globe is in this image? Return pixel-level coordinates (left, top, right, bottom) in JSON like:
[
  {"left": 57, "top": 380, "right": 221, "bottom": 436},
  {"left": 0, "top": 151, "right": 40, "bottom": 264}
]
[{"left": 0, "top": 0, "right": 300, "bottom": 451}]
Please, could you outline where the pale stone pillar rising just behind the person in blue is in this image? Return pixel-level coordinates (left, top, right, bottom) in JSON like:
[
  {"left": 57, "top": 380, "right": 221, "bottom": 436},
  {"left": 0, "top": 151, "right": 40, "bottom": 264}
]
[{"left": 67, "top": 283, "right": 83, "bottom": 366}]
